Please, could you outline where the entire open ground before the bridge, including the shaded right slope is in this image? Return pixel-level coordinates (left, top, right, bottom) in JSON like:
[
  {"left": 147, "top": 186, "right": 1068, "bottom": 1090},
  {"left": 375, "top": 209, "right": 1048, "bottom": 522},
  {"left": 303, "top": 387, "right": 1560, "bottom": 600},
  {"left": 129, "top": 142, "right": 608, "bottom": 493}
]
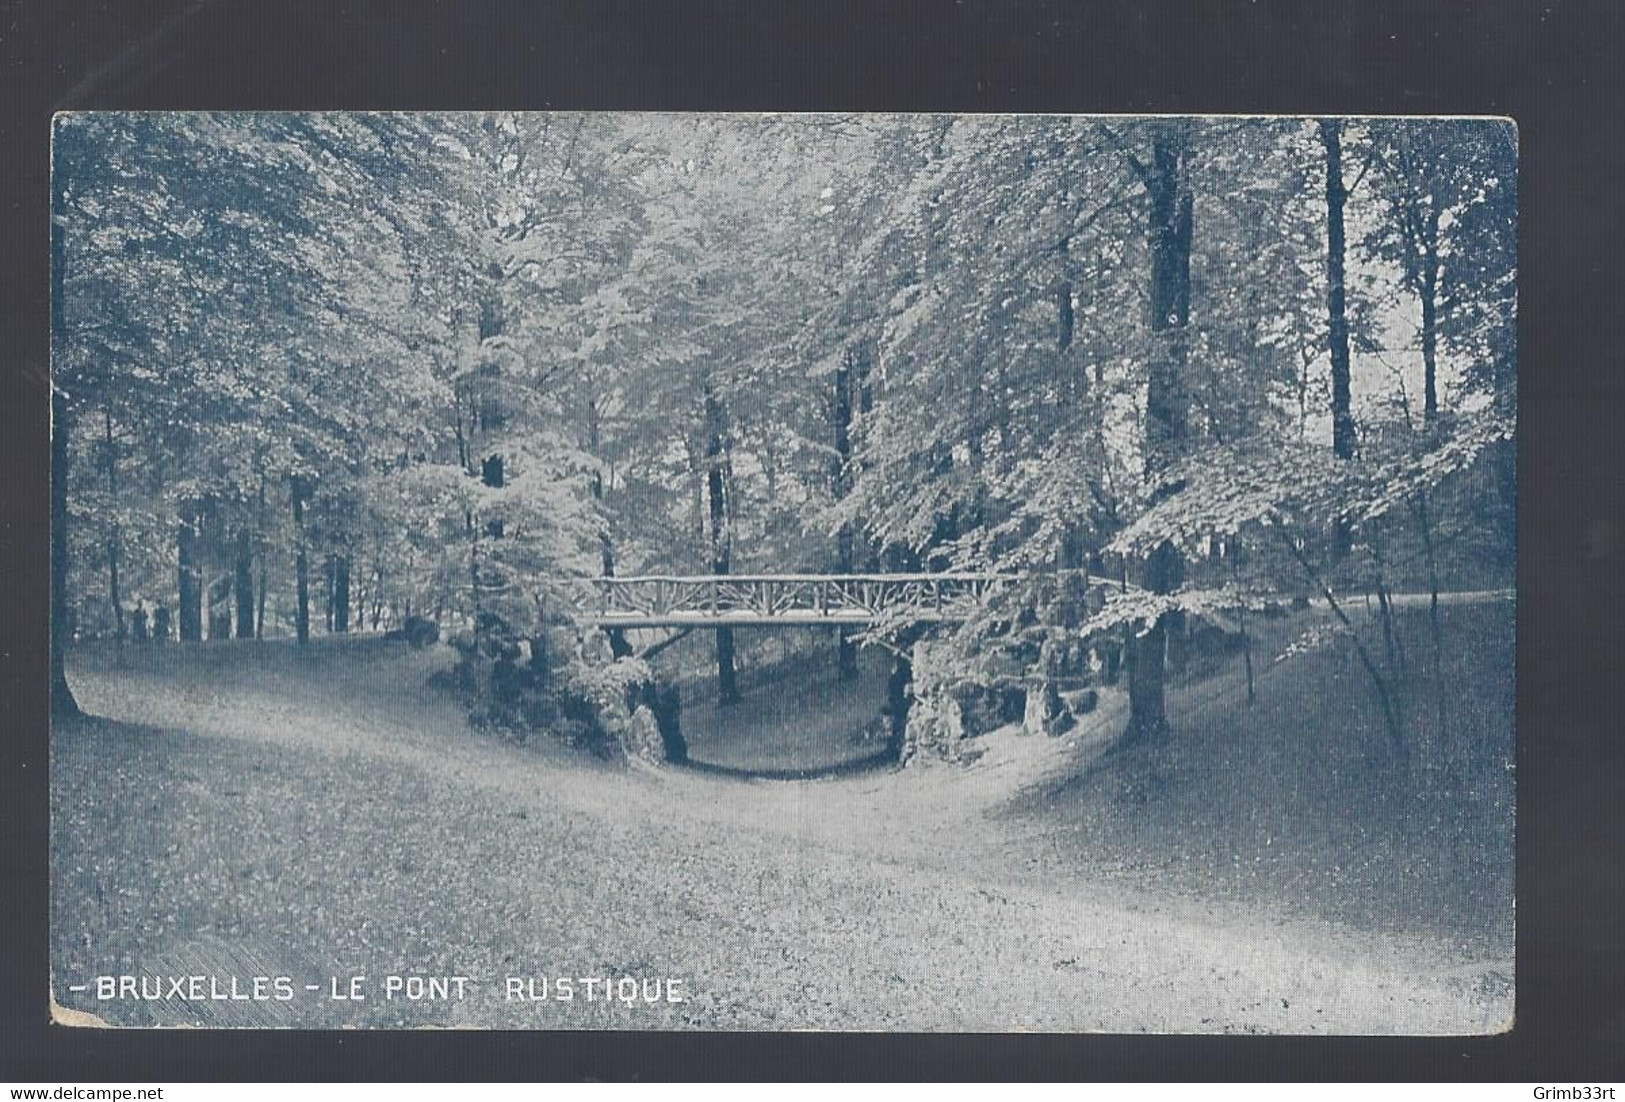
[{"left": 52, "top": 605, "right": 1513, "bottom": 1034}]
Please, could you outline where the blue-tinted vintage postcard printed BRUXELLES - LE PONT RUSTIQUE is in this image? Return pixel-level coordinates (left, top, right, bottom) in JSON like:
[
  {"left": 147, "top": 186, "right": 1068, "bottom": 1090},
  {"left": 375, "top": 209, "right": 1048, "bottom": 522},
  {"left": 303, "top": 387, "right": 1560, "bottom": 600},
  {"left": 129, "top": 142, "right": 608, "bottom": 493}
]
[{"left": 50, "top": 112, "right": 1518, "bottom": 1035}]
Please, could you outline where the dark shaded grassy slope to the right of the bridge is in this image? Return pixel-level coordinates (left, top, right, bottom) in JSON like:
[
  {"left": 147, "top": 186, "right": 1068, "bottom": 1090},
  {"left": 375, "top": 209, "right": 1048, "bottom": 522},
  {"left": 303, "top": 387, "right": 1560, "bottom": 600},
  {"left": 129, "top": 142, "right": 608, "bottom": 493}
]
[{"left": 1004, "top": 603, "right": 1515, "bottom": 955}]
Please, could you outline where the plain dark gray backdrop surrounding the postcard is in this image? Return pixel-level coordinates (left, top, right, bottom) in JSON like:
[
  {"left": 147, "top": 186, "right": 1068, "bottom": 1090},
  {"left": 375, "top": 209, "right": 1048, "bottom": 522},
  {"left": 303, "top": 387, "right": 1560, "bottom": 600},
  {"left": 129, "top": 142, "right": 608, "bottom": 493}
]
[{"left": 0, "top": 0, "right": 1625, "bottom": 1084}]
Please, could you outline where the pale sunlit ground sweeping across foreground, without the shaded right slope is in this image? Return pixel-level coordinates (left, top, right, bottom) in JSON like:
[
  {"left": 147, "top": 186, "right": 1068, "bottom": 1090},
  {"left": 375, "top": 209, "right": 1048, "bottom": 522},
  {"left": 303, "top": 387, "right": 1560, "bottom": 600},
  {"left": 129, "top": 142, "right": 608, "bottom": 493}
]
[{"left": 52, "top": 647, "right": 1511, "bottom": 1034}]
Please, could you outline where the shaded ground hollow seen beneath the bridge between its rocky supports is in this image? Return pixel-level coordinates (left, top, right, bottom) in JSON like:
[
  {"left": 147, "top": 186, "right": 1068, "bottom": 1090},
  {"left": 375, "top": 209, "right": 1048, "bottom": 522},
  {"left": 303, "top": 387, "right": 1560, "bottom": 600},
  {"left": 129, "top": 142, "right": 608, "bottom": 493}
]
[{"left": 683, "top": 647, "right": 895, "bottom": 780}]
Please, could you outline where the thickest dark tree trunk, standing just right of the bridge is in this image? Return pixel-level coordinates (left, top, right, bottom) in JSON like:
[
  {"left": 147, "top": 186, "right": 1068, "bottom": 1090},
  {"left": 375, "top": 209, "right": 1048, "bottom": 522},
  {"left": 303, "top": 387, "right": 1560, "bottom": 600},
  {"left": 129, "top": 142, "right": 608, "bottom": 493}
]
[{"left": 1128, "top": 124, "right": 1193, "bottom": 740}]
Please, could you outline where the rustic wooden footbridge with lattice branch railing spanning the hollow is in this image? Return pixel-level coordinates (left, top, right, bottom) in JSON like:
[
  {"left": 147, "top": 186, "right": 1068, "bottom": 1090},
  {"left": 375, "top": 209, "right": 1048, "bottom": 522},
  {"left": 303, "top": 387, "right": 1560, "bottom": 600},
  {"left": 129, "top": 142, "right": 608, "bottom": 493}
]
[{"left": 583, "top": 574, "right": 1121, "bottom": 629}]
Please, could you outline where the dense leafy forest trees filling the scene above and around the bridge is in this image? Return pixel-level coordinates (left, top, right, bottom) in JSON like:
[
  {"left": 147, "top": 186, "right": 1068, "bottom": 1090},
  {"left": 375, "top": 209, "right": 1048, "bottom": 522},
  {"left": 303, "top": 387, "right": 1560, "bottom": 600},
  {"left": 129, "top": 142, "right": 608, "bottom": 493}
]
[{"left": 52, "top": 114, "right": 1518, "bottom": 767}]
